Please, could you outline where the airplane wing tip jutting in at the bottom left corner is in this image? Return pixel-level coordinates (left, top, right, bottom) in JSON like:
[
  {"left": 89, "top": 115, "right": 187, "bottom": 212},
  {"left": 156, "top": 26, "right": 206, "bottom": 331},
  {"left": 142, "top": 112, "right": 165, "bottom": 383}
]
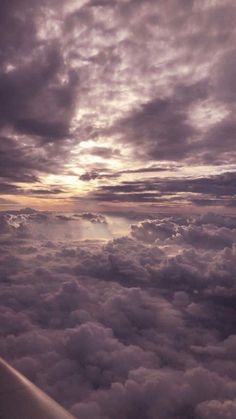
[{"left": 0, "top": 358, "right": 75, "bottom": 419}]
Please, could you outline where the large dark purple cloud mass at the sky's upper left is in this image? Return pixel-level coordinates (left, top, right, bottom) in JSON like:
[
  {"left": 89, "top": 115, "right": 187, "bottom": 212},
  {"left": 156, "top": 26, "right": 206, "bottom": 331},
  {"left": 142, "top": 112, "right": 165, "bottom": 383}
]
[{"left": 0, "top": 0, "right": 77, "bottom": 141}]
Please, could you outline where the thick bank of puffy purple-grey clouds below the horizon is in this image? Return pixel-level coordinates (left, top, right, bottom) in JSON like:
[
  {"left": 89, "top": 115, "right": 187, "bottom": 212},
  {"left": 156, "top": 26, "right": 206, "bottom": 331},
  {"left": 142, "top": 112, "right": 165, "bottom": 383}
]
[{"left": 0, "top": 209, "right": 236, "bottom": 419}]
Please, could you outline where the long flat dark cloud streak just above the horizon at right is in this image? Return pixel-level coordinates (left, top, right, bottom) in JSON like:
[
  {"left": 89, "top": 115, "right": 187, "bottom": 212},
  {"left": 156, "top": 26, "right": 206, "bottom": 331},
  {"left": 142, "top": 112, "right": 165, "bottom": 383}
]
[{"left": 91, "top": 172, "right": 236, "bottom": 205}]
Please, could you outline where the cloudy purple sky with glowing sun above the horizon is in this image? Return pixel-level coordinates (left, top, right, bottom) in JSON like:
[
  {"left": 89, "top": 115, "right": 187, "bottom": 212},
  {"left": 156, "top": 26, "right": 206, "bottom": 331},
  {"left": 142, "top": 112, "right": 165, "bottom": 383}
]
[{"left": 0, "top": 0, "right": 236, "bottom": 214}]
